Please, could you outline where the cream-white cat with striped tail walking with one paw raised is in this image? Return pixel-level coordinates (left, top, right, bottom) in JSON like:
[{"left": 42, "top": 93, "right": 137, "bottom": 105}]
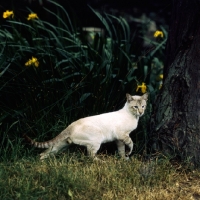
[{"left": 25, "top": 93, "right": 148, "bottom": 160}]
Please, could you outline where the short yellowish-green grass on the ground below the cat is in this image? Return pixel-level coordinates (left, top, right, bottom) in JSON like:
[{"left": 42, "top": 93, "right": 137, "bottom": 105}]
[{"left": 0, "top": 153, "right": 200, "bottom": 200}]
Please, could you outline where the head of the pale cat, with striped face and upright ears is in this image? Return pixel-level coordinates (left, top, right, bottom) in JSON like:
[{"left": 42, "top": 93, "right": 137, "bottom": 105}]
[{"left": 126, "top": 93, "right": 148, "bottom": 117}]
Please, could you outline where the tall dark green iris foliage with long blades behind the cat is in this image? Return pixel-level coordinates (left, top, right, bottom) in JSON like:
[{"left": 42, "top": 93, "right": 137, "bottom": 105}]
[{"left": 0, "top": 1, "right": 166, "bottom": 159}]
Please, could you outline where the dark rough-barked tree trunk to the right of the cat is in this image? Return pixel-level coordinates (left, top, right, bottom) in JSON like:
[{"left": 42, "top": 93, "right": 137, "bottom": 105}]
[{"left": 151, "top": 0, "right": 200, "bottom": 164}]
